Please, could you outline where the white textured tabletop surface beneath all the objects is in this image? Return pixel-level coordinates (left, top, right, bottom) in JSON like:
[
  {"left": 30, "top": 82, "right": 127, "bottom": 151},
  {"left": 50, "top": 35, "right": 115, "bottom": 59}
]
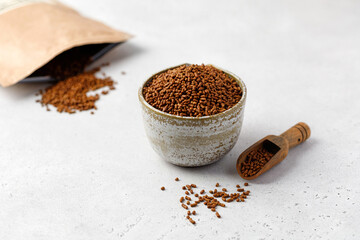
[{"left": 0, "top": 0, "right": 360, "bottom": 240}]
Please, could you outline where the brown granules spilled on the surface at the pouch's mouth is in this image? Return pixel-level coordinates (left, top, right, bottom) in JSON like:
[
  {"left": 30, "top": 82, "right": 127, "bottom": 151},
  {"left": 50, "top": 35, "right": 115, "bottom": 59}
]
[{"left": 39, "top": 68, "right": 114, "bottom": 113}]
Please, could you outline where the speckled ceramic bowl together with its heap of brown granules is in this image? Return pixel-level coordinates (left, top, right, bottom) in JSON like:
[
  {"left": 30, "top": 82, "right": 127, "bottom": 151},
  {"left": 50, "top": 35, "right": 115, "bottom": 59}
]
[{"left": 139, "top": 64, "right": 246, "bottom": 167}]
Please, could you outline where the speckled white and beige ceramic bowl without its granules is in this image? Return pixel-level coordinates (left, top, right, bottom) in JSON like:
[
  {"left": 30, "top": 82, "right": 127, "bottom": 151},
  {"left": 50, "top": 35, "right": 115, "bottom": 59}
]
[{"left": 138, "top": 64, "right": 247, "bottom": 167}]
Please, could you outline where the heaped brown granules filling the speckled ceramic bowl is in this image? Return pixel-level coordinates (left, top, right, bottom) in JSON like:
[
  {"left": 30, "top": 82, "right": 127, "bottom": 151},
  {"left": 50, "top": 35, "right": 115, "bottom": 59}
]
[{"left": 143, "top": 64, "right": 242, "bottom": 117}]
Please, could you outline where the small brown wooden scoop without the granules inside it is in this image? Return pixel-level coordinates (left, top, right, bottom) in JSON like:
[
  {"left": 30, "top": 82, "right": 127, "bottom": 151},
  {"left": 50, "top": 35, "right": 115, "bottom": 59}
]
[{"left": 236, "top": 122, "right": 311, "bottom": 180}]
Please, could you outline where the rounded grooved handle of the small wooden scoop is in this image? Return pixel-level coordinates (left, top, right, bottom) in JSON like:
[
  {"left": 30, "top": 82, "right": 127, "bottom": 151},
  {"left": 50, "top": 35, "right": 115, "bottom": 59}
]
[{"left": 280, "top": 122, "right": 311, "bottom": 148}]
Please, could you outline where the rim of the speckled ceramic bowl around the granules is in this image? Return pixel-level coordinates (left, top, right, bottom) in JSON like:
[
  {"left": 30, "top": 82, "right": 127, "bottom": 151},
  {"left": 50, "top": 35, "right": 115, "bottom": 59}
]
[{"left": 138, "top": 63, "right": 247, "bottom": 120}]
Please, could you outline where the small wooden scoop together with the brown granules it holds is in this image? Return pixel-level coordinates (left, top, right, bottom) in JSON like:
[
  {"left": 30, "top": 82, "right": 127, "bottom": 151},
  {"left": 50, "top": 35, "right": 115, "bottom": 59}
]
[{"left": 236, "top": 122, "right": 311, "bottom": 180}]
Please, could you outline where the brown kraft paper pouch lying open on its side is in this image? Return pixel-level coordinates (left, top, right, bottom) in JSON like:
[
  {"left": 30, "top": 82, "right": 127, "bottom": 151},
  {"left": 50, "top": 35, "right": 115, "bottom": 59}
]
[{"left": 0, "top": 0, "right": 131, "bottom": 87}]
